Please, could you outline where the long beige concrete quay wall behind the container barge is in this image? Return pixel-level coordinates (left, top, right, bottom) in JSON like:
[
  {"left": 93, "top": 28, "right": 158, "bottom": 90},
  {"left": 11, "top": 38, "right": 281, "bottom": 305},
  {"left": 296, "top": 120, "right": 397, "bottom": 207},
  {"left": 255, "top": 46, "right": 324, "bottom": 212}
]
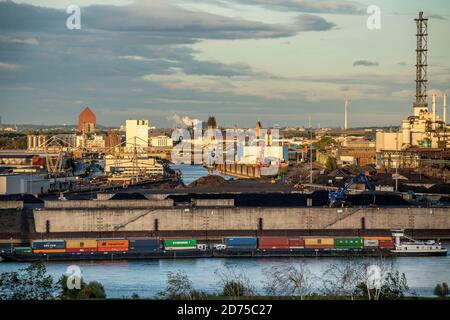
[{"left": 33, "top": 206, "right": 450, "bottom": 233}]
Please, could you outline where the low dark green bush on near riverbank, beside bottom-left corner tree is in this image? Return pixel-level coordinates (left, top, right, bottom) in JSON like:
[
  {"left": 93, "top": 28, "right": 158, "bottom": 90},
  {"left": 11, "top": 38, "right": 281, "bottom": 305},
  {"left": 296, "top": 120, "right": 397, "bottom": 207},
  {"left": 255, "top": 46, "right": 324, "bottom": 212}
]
[{"left": 58, "top": 275, "right": 106, "bottom": 300}]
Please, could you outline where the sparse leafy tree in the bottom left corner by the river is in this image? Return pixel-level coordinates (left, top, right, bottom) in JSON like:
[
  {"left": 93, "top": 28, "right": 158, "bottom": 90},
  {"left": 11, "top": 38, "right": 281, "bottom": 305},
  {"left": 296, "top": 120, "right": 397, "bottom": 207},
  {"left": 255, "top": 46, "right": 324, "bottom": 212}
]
[{"left": 0, "top": 263, "right": 56, "bottom": 300}]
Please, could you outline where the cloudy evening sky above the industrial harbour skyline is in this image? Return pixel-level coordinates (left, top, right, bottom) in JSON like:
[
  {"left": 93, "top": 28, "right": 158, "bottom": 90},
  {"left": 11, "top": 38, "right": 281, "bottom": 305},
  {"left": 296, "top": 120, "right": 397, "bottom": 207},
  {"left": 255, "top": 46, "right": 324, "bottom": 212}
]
[{"left": 0, "top": 0, "right": 450, "bottom": 127}]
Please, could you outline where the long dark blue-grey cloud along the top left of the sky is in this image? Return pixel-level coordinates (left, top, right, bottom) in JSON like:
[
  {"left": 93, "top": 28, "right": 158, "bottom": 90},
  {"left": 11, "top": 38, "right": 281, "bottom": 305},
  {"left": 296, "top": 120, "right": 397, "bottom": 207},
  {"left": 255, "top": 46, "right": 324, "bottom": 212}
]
[{"left": 0, "top": 0, "right": 295, "bottom": 42}]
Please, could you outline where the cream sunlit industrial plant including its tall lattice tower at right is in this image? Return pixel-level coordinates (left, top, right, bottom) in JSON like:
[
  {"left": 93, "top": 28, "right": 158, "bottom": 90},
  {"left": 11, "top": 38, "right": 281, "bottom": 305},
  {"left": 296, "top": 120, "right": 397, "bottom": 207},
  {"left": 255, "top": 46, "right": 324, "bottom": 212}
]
[{"left": 376, "top": 12, "right": 450, "bottom": 168}]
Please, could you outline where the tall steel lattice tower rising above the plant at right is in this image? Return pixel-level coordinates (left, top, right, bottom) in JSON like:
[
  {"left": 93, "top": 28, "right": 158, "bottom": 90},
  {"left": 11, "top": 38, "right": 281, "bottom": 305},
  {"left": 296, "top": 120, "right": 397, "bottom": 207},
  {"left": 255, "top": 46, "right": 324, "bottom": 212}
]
[{"left": 414, "top": 12, "right": 428, "bottom": 108}]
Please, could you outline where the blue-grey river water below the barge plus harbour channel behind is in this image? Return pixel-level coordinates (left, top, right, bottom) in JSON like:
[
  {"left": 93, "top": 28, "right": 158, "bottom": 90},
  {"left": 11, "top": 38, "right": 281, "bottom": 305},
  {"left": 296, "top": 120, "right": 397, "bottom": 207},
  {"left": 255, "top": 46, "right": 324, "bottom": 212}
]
[{"left": 0, "top": 166, "right": 450, "bottom": 298}]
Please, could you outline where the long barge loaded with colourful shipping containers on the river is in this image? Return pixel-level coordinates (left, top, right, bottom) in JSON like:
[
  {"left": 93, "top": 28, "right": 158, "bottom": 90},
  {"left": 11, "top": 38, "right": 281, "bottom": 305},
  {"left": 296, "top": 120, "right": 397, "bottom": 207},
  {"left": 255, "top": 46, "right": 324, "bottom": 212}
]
[{"left": 0, "top": 230, "right": 447, "bottom": 262}]
